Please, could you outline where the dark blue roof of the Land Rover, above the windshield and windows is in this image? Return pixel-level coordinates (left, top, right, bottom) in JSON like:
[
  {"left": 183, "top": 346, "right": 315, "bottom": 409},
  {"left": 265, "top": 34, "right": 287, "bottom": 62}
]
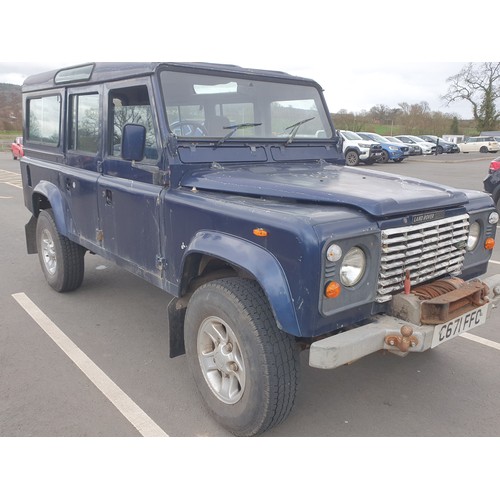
[{"left": 23, "top": 62, "right": 317, "bottom": 92}]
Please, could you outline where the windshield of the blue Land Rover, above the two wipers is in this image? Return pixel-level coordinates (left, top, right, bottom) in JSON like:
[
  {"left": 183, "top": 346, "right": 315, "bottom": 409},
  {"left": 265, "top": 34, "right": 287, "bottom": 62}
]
[{"left": 161, "top": 71, "right": 333, "bottom": 140}]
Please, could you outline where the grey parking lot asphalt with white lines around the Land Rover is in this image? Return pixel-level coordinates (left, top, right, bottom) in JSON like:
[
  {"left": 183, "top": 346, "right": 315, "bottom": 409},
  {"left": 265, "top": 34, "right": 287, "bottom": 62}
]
[{"left": 0, "top": 150, "right": 500, "bottom": 437}]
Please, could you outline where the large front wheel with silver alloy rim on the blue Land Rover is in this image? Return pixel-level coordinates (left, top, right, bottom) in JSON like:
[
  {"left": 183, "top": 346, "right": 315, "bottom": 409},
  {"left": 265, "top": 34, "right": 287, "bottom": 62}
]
[{"left": 184, "top": 278, "right": 299, "bottom": 436}]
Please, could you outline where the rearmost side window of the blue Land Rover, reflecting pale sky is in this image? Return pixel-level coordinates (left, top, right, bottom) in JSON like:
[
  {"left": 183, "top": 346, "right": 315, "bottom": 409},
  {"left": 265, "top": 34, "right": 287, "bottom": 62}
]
[{"left": 26, "top": 95, "right": 61, "bottom": 146}]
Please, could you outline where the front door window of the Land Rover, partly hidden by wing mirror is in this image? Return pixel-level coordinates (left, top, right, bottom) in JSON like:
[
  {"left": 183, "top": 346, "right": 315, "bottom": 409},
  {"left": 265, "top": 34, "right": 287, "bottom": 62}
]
[{"left": 108, "top": 85, "right": 158, "bottom": 160}]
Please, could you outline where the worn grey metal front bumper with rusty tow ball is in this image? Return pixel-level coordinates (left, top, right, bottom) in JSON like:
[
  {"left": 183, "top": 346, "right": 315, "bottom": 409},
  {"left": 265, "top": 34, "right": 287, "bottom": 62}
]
[{"left": 309, "top": 274, "right": 500, "bottom": 369}]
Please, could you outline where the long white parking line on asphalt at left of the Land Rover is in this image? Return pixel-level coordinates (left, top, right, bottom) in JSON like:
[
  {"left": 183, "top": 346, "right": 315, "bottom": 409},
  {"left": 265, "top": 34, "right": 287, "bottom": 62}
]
[{"left": 12, "top": 293, "right": 168, "bottom": 437}]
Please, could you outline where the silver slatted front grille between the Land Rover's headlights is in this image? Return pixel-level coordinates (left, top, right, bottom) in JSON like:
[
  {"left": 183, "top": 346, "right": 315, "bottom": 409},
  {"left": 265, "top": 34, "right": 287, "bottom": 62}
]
[{"left": 376, "top": 214, "right": 469, "bottom": 302}]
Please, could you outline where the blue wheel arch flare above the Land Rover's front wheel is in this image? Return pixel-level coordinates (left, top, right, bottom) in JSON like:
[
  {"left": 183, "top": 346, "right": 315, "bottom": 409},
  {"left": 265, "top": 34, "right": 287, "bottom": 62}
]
[{"left": 183, "top": 231, "right": 300, "bottom": 336}]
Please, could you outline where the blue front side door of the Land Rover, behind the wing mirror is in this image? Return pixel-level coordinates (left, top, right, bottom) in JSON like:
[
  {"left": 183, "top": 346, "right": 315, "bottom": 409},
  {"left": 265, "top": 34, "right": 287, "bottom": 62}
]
[{"left": 98, "top": 79, "right": 163, "bottom": 281}]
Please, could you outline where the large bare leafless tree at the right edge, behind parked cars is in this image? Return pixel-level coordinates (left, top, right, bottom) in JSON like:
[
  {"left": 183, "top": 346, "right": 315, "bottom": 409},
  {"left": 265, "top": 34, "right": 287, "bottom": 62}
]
[{"left": 441, "top": 62, "right": 500, "bottom": 132}]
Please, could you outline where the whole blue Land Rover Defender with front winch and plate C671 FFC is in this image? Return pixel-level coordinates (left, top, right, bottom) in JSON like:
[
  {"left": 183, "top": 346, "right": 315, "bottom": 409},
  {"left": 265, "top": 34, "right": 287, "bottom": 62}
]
[{"left": 21, "top": 63, "right": 500, "bottom": 436}]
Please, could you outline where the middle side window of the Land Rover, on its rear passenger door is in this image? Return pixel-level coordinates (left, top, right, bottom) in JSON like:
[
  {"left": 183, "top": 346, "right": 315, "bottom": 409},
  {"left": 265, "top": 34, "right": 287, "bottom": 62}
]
[{"left": 68, "top": 94, "right": 99, "bottom": 154}]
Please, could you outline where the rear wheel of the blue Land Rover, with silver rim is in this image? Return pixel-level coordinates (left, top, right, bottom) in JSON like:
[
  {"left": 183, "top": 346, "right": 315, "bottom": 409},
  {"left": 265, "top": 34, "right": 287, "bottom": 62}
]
[{"left": 36, "top": 209, "right": 85, "bottom": 292}]
